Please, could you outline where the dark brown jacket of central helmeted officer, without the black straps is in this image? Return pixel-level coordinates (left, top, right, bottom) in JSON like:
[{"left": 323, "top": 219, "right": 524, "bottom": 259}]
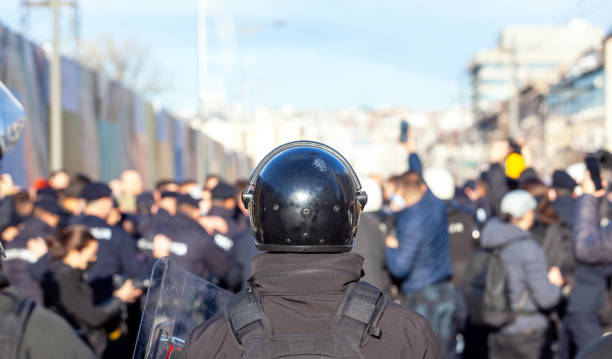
[{"left": 184, "top": 253, "right": 440, "bottom": 359}]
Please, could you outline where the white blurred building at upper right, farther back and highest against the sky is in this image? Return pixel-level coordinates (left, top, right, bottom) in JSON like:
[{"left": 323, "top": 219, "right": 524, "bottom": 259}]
[{"left": 469, "top": 20, "right": 604, "bottom": 119}]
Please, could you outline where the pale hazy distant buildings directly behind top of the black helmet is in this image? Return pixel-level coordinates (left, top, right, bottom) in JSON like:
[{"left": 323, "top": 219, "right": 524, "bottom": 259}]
[{"left": 198, "top": 105, "right": 485, "bottom": 181}]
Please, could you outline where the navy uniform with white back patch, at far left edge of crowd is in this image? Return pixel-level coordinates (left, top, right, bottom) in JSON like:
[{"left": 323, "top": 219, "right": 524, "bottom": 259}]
[{"left": 2, "top": 217, "right": 55, "bottom": 304}]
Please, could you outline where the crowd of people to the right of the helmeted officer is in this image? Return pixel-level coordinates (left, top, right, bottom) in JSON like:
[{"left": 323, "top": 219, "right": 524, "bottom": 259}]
[{"left": 355, "top": 139, "right": 612, "bottom": 358}]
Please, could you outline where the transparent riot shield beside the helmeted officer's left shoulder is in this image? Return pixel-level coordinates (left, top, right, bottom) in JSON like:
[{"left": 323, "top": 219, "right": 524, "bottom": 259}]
[{"left": 133, "top": 257, "right": 231, "bottom": 359}]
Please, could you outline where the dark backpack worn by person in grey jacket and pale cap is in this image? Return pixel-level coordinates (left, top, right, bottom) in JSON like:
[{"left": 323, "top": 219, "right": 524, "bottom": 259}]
[{"left": 464, "top": 242, "right": 526, "bottom": 328}]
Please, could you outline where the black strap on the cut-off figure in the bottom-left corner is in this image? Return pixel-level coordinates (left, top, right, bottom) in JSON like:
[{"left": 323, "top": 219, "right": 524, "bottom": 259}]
[{"left": 0, "top": 291, "right": 35, "bottom": 359}]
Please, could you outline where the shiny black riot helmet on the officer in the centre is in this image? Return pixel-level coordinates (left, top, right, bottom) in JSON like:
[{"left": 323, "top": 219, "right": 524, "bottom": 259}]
[{"left": 242, "top": 141, "right": 367, "bottom": 253}]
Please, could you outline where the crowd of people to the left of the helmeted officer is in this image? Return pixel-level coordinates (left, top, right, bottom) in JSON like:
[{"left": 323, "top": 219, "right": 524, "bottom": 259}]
[{"left": 0, "top": 170, "right": 257, "bottom": 358}]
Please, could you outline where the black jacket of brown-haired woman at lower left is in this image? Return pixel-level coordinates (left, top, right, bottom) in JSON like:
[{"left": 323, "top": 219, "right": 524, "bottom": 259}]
[{"left": 43, "top": 260, "right": 122, "bottom": 354}]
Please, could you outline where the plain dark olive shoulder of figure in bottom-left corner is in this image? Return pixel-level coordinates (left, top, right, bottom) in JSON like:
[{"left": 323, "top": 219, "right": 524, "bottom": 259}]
[{"left": 19, "top": 306, "right": 95, "bottom": 359}]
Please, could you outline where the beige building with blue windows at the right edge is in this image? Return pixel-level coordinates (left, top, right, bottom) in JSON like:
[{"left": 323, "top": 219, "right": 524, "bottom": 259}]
[{"left": 468, "top": 27, "right": 612, "bottom": 176}]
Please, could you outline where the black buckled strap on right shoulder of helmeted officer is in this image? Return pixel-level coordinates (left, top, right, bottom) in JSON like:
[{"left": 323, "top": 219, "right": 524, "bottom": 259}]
[{"left": 333, "top": 282, "right": 387, "bottom": 347}]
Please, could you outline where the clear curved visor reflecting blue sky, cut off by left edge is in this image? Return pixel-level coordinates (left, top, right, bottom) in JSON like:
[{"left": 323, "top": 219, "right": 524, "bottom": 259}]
[{"left": 0, "top": 82, "right": 25, "bottom": 158}]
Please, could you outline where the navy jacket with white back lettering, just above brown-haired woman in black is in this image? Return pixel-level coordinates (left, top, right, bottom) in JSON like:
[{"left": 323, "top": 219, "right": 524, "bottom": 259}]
[{"left": 70, "top": 216, "right": 147, "bottom": 303}]
